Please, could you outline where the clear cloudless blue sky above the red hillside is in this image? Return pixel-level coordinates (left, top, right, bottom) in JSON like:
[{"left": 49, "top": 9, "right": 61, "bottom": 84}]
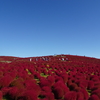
[{"left": 0, "top": 0, "right": 100, "bottom": 58}]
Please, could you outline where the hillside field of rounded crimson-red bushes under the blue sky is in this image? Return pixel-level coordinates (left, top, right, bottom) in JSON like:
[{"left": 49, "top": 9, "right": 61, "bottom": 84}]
[{"left": 0, "top": 55, "right": 100, "bottom": 100}]
